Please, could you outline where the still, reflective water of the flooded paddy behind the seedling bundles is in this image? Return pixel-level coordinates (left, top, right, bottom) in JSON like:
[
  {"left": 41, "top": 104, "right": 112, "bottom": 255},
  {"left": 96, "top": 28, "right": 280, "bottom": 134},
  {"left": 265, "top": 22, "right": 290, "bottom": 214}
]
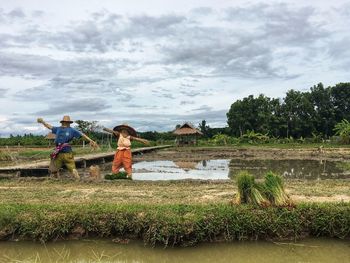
[{"left": 96, "top": 159, "right": 350, "bottom": 180}]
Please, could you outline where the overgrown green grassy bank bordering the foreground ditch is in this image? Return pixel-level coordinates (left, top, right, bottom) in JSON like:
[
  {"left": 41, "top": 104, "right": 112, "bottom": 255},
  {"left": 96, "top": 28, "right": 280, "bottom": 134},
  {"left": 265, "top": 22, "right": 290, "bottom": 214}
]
[{"left": 0, "top": 203, "right": 350, "bottom": 246}]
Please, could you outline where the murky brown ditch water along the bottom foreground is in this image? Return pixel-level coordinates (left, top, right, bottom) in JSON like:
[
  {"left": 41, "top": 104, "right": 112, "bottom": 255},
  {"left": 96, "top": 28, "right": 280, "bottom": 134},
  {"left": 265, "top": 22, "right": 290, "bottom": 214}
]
[{"left": 0, "top": 239, "right": 350, "bottom": 263}]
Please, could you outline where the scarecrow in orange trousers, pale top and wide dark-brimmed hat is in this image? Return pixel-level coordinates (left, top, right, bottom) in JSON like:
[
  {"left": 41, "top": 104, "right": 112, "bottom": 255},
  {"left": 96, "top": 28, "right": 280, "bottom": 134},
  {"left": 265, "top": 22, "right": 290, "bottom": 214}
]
[{"left": 104, "top": 123, "right": 149, "bottom": 178}]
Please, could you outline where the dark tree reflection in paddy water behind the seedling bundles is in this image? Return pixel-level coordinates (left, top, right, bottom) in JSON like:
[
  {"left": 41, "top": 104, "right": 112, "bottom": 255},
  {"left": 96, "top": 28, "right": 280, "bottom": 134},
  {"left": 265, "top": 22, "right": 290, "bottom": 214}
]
[{"left": 229, "top": 159, "right": 350, "bottom": 179}]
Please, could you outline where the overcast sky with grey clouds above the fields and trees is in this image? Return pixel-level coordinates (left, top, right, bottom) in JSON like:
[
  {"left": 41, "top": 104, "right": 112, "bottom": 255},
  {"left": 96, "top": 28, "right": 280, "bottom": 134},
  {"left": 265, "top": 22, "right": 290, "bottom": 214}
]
[{"left": 0, "top": 0, "right": 350, "bottom": 137}]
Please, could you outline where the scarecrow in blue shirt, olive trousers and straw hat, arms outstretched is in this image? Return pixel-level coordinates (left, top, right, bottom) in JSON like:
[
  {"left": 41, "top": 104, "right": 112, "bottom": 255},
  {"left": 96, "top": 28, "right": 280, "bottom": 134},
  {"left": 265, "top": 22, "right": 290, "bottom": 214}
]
[{"left": 37, "top": 116, "right": 98, "bottom": 180}]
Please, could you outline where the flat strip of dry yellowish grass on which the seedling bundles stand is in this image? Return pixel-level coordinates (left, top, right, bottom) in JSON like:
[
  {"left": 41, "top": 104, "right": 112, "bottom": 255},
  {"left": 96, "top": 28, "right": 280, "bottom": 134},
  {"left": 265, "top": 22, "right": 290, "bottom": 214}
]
[{"left": 0, "top": 178, "right": 350, "bottom": 205}]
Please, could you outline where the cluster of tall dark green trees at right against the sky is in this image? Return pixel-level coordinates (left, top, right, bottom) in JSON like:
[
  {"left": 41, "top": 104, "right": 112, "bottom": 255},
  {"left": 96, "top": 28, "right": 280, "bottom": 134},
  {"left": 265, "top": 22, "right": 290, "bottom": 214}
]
[{"left": 227, "top": 83, "right": 350, "bottom": 138}]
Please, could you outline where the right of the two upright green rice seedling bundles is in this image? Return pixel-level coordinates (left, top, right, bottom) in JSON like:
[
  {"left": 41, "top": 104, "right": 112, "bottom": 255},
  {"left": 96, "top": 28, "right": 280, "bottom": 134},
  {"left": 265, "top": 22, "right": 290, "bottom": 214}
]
[{"left": 264, "top": 172, "right": 290, "bottom": 206}]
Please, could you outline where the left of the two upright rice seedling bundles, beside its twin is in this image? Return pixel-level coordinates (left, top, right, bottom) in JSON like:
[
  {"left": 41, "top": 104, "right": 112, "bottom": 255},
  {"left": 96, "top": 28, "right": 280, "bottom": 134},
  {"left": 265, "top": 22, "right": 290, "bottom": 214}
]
[{"left": 235, "top": 171, "right": 268, "bottom": 206}]
